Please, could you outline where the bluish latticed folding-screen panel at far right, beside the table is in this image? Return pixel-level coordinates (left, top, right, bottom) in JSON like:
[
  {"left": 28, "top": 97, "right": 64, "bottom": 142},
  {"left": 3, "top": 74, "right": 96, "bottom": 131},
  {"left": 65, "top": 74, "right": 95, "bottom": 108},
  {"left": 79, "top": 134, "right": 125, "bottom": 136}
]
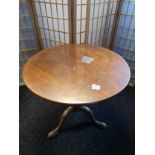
[{"left": 113, "top": 0, "right": 135, "bottom": 84}]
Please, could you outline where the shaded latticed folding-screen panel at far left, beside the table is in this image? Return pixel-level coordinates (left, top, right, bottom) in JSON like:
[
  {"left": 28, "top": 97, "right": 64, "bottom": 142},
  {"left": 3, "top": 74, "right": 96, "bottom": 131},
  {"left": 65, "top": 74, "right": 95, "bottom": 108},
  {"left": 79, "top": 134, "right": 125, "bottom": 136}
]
[{"left": 19, "top": 0, "right": 40, "bottom": 85}]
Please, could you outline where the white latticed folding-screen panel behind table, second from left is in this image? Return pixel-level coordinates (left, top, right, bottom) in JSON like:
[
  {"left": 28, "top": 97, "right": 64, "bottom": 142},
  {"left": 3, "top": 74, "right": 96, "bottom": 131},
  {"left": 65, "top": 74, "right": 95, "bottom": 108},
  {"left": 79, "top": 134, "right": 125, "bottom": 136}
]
[{"left": 34, "top": 0, "right": 70, "bottom": 48}]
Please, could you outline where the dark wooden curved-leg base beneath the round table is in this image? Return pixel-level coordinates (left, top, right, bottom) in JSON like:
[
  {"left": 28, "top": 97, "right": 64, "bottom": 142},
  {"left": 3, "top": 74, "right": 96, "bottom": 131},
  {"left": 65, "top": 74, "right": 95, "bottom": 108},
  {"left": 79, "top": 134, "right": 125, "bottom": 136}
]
[{"left": 48, "top": 106, "right": 107, "bottom": 138}]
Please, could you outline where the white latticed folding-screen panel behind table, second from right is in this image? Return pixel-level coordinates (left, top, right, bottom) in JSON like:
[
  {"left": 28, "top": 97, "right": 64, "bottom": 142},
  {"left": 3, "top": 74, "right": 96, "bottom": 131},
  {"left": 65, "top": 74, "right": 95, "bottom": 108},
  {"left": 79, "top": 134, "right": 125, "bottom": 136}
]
[{"left": 87, "top": 0, "right": 118, "bottom": 47}]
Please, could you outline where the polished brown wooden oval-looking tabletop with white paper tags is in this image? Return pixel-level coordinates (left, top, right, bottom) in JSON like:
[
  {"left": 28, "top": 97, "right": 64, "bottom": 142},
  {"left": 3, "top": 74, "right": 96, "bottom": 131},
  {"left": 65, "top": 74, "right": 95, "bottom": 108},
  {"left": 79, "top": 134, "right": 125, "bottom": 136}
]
[{"left": 23, "top": 44, "right": 130, "bottom": 105}]
